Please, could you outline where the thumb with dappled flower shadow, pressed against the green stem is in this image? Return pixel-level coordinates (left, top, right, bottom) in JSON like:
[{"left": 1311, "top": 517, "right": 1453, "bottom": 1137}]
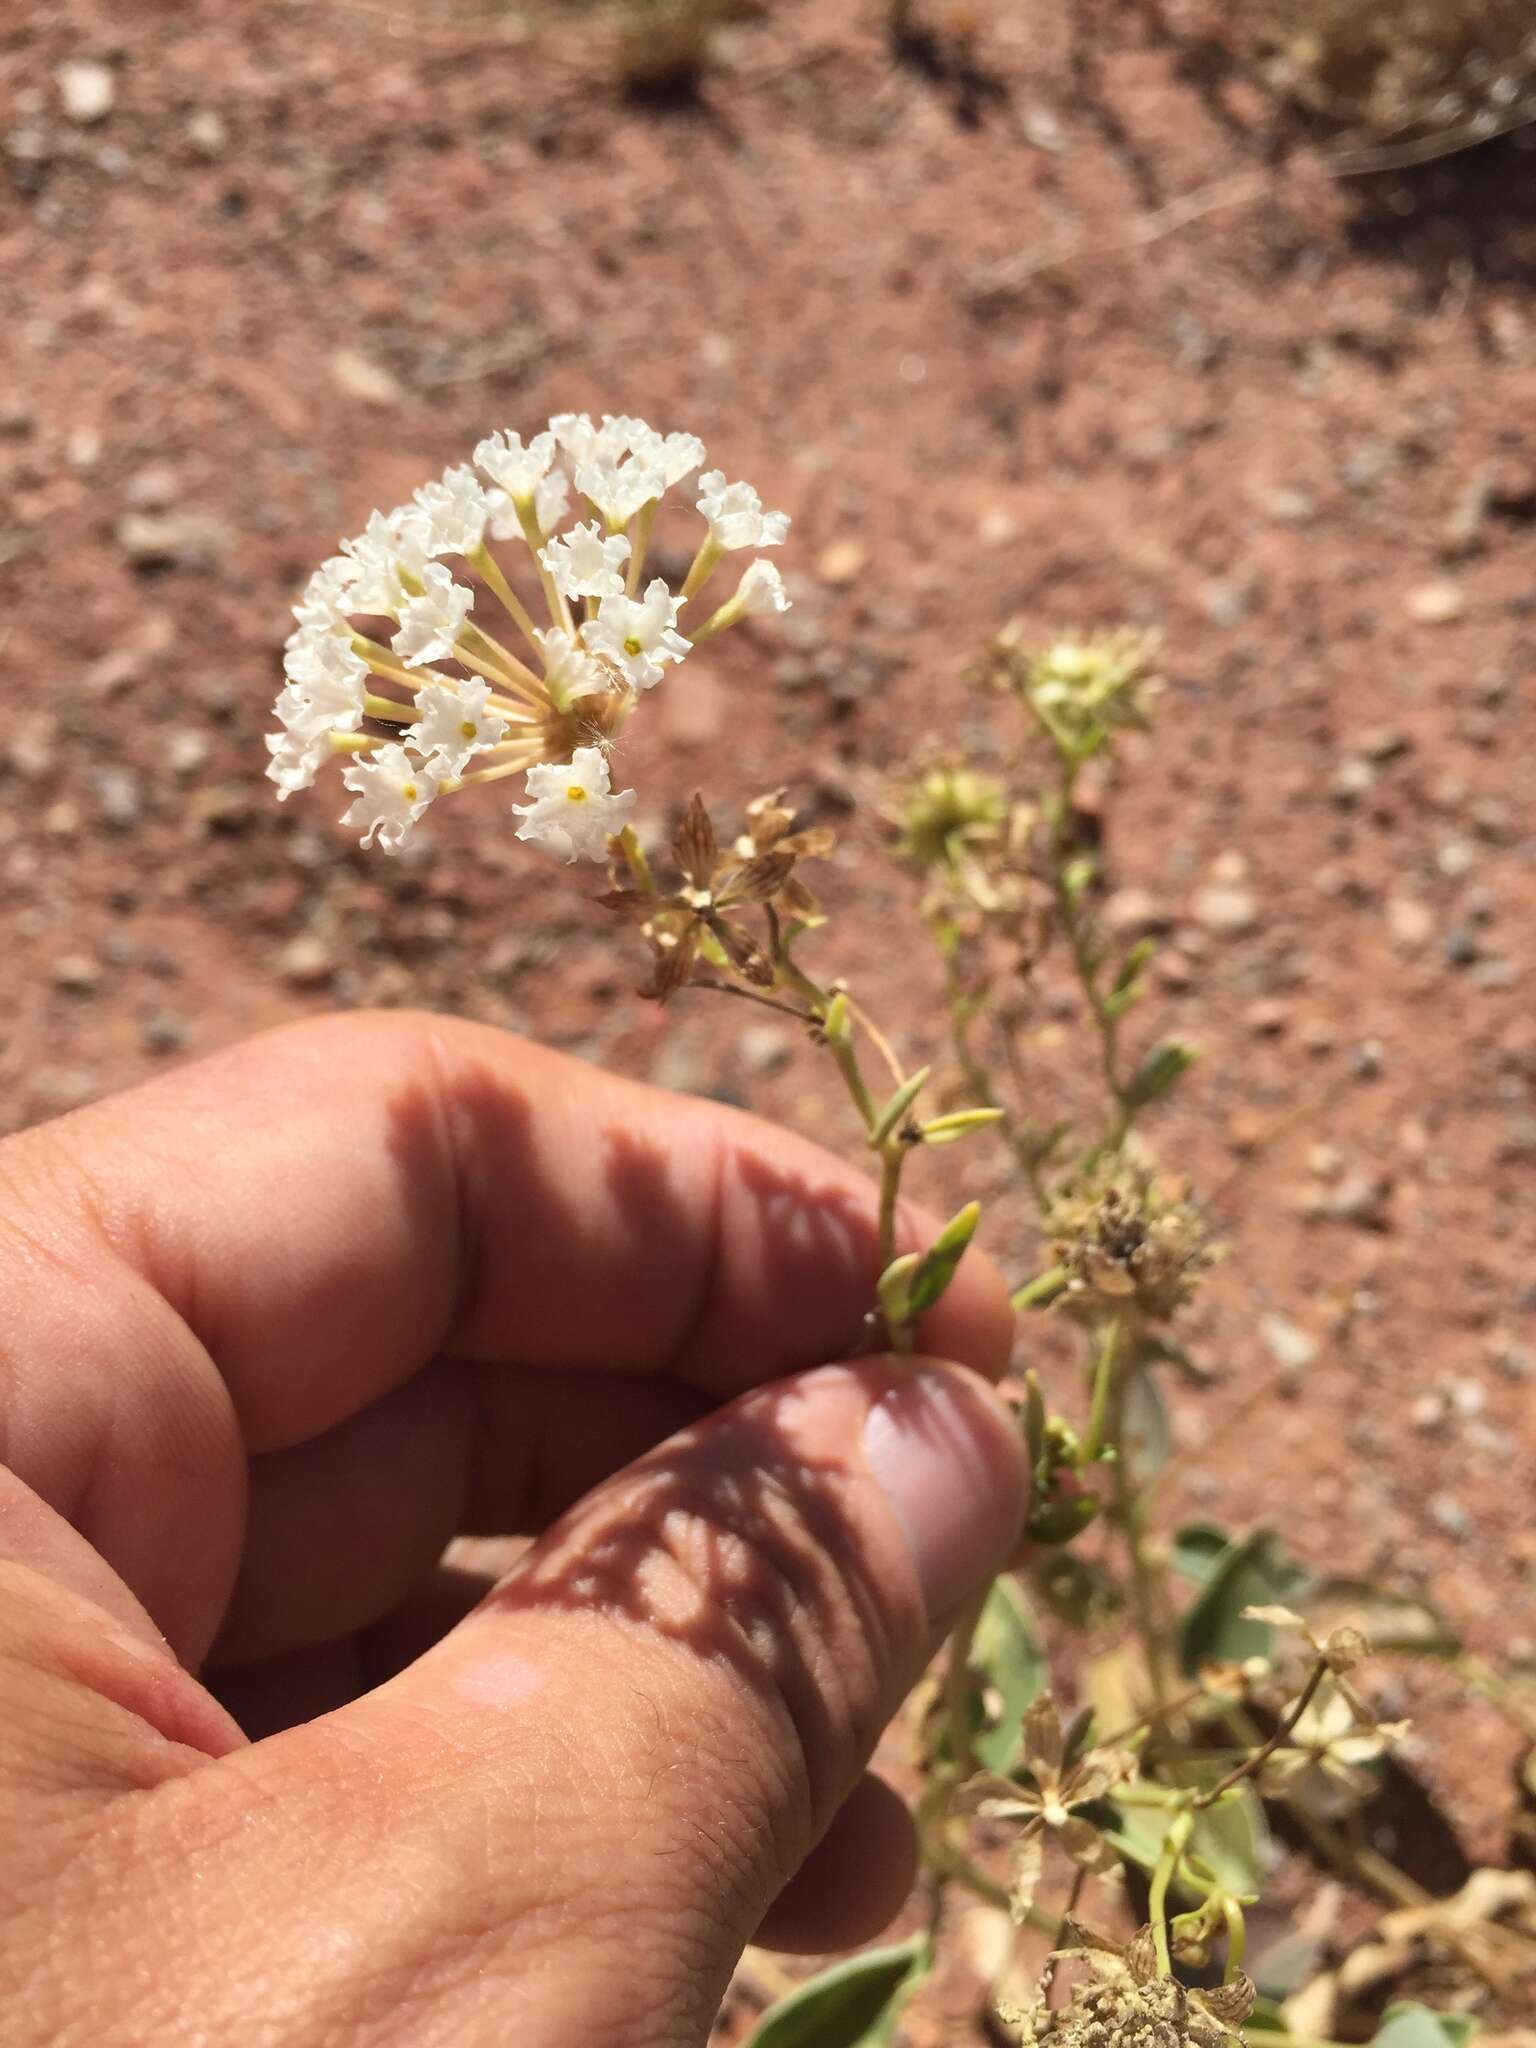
[{"left": 153, "top": 1360, "right": 1026, "bottom": 2048}]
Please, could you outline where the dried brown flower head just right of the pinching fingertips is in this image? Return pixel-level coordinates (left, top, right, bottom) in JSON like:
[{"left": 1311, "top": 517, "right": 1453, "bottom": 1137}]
[{"left": 1047, "top": 1157, "right": 1214, "bottom": 1323}]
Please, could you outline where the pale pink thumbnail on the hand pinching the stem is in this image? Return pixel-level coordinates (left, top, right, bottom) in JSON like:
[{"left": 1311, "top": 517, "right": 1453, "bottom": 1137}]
[{"left": 864, "top": 1364, "right": 1028, "bottom": 1620}]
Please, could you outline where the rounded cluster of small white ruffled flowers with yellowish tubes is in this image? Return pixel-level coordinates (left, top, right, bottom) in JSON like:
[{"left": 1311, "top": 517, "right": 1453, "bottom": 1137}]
[{"left": 266, "top": 412, "right": 788, "bottom": 860}]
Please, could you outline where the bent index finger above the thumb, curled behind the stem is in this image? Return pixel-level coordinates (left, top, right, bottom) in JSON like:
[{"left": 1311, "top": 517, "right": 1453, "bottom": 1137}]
[{"left": 8, "top": 1016, "right": 1012, "bottom": 1450}]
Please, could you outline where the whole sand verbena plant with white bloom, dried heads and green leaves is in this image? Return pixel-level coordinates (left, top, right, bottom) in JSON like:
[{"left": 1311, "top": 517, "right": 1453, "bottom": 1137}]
[{"left": 268, "top": 414, "right": 1536, "bottom": 2048}]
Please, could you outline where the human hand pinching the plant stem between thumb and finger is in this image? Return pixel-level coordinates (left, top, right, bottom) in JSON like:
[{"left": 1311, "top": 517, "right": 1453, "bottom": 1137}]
[{"left": 0, "top": 1018, "right": 1026, "bottom": 2048}]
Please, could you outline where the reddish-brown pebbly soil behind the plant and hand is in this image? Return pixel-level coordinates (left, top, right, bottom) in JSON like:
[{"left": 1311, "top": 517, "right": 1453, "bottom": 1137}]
[{"left": 0, "top": 0, "right": 1536, "bottom": 2031}]
